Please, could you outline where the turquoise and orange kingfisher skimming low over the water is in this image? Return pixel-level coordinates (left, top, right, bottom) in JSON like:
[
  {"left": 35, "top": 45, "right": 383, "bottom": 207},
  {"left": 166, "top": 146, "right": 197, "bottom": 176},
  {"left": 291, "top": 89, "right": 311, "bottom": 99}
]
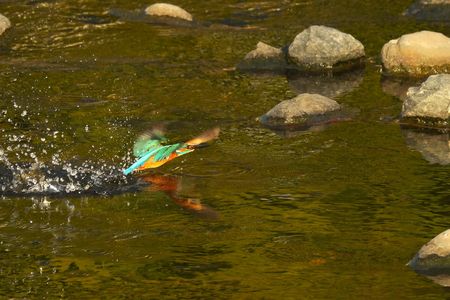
[{"left": 123, "top": 127, "right": 220, "bottom": 175}]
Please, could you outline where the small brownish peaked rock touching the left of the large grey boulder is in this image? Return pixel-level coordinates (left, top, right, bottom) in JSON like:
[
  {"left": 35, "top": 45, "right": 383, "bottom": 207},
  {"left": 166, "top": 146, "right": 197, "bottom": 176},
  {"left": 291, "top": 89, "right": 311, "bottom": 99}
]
[{"left": 237, "top": 42, "right": 286, "bottom": 71}]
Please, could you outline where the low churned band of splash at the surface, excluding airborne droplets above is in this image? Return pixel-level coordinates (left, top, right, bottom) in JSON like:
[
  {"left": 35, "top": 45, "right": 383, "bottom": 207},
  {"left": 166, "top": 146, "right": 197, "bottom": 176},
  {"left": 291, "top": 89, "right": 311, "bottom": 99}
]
[{"left": 0, "top": 149, "right": 142, "bottom": 195}]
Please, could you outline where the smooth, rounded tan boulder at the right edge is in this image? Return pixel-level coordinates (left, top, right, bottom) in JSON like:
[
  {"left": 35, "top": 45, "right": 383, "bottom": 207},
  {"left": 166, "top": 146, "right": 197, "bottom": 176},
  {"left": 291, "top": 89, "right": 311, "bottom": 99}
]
[{"left": 381, "top": 31, "right": 450, "bottom": 76}]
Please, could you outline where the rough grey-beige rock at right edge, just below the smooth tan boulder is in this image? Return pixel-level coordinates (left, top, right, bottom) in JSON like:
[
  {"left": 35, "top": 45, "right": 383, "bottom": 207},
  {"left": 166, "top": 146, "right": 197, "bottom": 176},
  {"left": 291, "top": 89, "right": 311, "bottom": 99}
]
[{"left": 402, "top": 74, "right": 450, "bottom": 128}]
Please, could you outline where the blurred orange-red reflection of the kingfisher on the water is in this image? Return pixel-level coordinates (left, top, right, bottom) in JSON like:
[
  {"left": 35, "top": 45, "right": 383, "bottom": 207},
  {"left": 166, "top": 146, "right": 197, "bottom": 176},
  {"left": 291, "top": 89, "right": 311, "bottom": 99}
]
[{"left": 141, "top": 174, "right": 219, "bottom": 220}]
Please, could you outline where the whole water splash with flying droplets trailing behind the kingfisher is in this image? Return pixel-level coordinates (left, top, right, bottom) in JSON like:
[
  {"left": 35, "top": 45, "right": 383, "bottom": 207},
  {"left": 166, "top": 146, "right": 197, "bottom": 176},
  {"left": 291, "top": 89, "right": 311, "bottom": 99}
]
[{"left": 0, "top": 102, "right": 143, "bottom": 195}]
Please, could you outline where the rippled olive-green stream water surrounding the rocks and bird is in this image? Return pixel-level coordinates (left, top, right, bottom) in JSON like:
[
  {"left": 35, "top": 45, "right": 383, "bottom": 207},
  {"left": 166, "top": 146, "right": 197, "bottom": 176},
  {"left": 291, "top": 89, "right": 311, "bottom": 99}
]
[{"left": 0, "top": 0, "right": 450, "bottom": 299}]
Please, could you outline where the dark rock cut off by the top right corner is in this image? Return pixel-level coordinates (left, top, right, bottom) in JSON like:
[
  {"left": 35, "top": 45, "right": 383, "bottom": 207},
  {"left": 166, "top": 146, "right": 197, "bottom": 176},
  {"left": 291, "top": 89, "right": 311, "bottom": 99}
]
[{"left": 403, "top": 0, "right": 450, "bottom": 22}]
